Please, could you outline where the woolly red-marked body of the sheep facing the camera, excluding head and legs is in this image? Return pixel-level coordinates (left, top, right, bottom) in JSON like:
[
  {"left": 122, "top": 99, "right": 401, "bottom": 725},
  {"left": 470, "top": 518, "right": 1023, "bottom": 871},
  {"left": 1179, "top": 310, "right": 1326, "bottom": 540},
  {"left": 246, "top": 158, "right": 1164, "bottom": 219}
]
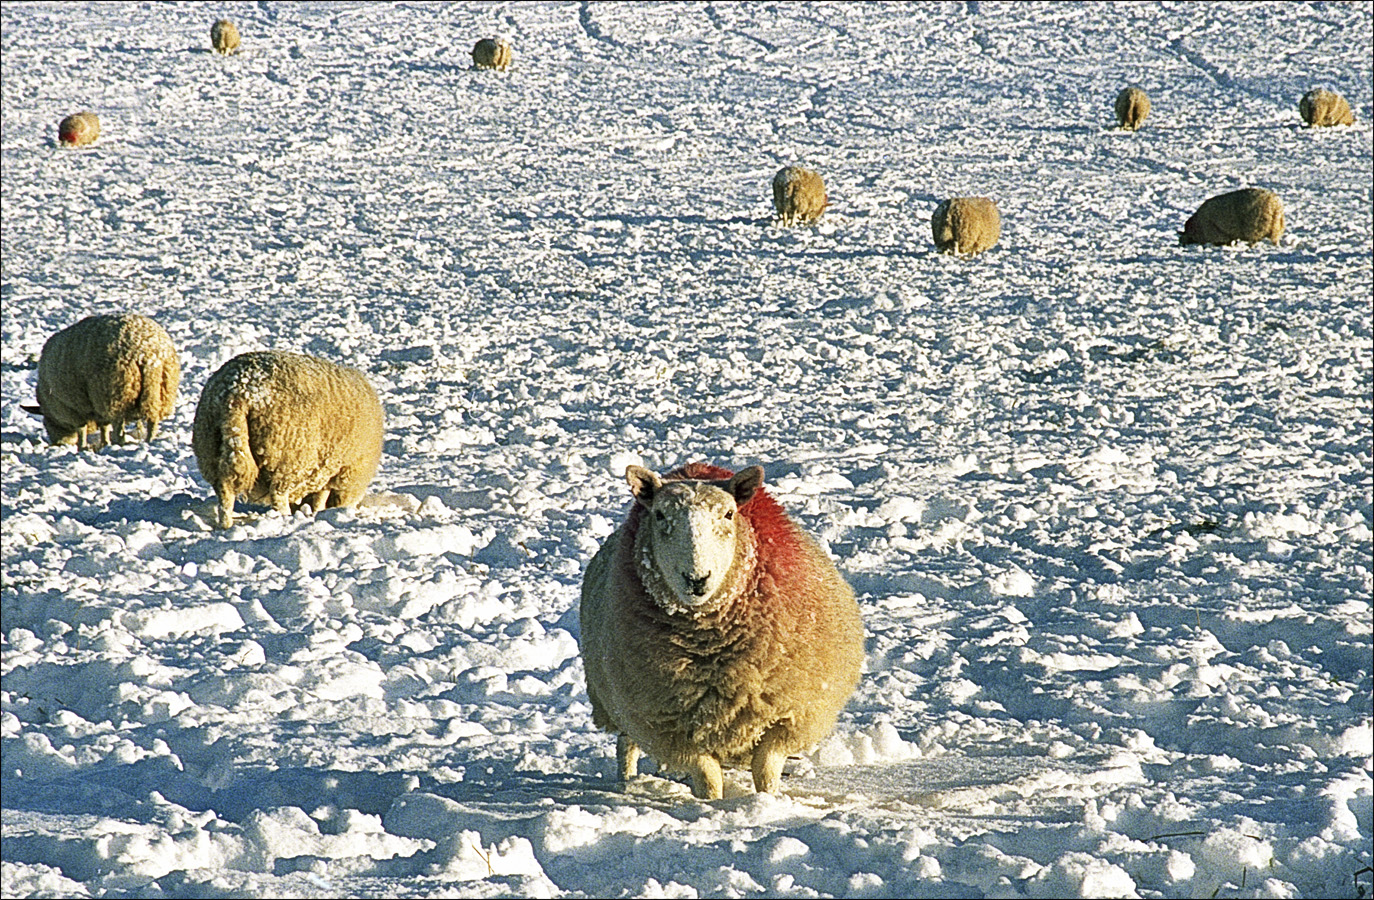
[{"left": 580, "top": 463, "right": 863, "bottom": 771}]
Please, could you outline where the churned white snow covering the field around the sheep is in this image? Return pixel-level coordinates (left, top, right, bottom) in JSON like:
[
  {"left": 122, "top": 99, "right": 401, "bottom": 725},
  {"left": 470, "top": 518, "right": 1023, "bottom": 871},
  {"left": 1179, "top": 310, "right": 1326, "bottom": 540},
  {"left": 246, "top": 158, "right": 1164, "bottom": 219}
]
[{"left": 0, "top": 3, "right": 1374, "bottom": 897}]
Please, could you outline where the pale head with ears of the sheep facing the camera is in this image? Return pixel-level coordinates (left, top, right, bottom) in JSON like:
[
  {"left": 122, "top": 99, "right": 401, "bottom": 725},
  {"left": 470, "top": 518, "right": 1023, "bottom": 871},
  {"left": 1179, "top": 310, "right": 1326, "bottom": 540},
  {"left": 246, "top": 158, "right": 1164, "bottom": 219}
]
[{"left": 625, "top": 466, "right": 764, "bottom": 609}]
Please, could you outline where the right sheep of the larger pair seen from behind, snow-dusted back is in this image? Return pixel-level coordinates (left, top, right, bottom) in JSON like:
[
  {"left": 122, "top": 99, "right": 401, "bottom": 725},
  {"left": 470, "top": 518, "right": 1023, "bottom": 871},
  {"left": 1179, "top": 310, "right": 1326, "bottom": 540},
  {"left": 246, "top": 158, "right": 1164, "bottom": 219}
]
[{"left": 191, "top": 350, "right": 382, "bottom": 528}]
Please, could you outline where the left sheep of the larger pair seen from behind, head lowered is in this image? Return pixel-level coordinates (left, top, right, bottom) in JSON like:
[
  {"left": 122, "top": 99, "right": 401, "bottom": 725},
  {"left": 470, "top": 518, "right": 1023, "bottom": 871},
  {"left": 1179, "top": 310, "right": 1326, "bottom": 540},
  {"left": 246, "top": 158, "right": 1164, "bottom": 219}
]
[{"left": 25, "top": 313, "right": 181, "bottom": 449}]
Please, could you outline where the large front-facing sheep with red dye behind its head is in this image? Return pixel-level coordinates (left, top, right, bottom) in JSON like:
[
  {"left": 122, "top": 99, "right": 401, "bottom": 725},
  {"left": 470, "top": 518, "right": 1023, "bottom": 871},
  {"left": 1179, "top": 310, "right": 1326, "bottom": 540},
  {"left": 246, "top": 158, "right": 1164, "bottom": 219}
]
[{"left": 578, "top": 463, "right": 864, "bottom": 800}]
